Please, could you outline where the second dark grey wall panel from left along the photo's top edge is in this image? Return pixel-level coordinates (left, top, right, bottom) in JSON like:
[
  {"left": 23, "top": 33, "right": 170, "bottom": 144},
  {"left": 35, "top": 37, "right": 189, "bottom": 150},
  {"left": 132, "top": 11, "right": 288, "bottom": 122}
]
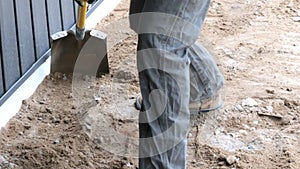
[{"left": 15, "top": 0, "right": 35, "bottom": 75}]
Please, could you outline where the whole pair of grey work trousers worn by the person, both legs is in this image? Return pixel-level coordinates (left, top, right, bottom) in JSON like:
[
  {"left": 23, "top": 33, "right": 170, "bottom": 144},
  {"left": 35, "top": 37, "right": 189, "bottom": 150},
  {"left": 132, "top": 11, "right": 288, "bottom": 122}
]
[{"left": 130, "top": 0, "right": 224, "bottom": 169}]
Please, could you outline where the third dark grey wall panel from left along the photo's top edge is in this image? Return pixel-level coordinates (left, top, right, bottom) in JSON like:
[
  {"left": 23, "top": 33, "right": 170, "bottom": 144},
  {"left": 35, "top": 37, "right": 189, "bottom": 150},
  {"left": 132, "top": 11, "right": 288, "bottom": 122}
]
[{"left": 31, "top": 0, "right": 50, "bottom": 59}]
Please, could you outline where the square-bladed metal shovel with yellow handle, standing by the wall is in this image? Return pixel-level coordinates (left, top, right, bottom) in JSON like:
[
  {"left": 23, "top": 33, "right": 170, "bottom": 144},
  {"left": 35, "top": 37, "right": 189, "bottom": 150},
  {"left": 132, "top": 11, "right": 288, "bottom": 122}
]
[{"left": 51, "top": 0, "right": 109, "bottom": 77}]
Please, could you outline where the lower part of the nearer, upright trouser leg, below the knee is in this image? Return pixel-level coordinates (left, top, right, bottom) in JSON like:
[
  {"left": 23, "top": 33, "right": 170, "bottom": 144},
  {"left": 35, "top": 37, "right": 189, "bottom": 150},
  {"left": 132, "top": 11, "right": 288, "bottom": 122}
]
[{"left": 137, "top": 34, "right": 189, "bottom": 169}]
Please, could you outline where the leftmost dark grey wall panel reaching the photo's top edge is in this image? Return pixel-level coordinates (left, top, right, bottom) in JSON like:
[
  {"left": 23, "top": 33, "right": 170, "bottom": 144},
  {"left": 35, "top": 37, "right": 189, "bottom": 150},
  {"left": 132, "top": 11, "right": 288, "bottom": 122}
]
[{"left": 0, "top": 0, "right": 20, "bottom": 91}]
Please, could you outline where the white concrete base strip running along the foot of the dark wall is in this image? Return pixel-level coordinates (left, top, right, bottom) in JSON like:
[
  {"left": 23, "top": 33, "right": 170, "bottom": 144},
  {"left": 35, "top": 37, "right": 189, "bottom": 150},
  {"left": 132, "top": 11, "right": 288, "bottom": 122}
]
[{"left": 0, "top": 0, "right": 121, "bottom": 128}]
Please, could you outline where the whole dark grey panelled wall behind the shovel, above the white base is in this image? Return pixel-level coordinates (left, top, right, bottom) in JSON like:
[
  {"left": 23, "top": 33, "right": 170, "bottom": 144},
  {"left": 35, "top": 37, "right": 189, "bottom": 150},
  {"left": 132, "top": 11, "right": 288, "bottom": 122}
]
[{"left": 0, "top": 0, "right": 102, "bottom": 105}]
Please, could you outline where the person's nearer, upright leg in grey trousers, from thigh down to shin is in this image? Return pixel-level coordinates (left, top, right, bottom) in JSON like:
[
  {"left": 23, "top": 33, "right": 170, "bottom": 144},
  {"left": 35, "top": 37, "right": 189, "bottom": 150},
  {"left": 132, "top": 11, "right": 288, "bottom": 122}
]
[{"left": 133, "top": 0, "right": 214, "bottom": 169}]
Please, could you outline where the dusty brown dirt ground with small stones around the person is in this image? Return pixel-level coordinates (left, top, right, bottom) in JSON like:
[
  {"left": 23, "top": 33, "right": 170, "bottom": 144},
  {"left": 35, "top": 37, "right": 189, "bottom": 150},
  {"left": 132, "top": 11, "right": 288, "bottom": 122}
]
[{"left": 0, "top": 0, "right": 300, "bottom": 169}]
